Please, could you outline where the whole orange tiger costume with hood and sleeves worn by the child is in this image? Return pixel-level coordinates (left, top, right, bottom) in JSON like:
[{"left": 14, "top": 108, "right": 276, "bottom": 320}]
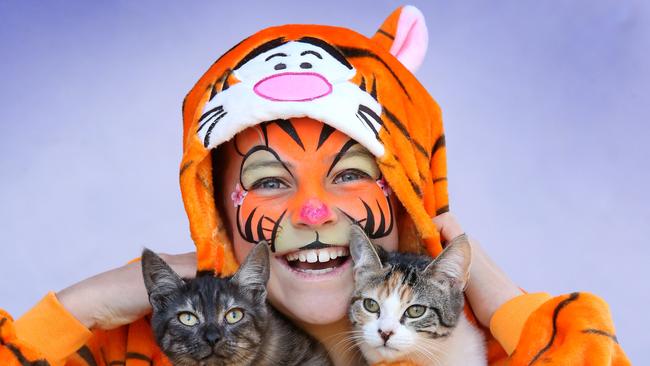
[{"left": 0, "top": 6, "right": 629, "bottom": 366}]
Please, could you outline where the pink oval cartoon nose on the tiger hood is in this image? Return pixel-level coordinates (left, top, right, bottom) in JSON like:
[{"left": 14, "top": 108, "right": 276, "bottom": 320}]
[{"left": 253, "top": 72, "right": 332, "bottom": 102}]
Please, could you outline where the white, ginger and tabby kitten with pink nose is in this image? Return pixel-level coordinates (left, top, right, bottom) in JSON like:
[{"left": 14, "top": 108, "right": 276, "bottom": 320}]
[{"left": 349, "top": 226, "right": 486, "bottom": 366}]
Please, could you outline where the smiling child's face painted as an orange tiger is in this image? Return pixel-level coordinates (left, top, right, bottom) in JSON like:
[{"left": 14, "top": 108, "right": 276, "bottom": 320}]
[{"left": 222, "top": 118, "right": 397, "bottom": 324}]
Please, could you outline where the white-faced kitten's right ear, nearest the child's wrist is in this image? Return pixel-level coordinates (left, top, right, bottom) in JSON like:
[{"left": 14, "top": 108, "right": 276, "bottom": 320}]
[{"left": 425, "top": 234, "right": 472, "bottom": 288}]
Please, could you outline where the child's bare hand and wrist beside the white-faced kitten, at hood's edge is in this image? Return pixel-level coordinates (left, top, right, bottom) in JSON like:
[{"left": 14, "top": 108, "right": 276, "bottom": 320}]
[{"left": 433, "top": 212, "right": 523, "bottom": 327}]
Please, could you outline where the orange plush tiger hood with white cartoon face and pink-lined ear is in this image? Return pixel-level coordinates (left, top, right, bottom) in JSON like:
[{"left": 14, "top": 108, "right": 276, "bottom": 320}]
[{"left": 180, "top": 6, "right": 448, "bottom": 274}]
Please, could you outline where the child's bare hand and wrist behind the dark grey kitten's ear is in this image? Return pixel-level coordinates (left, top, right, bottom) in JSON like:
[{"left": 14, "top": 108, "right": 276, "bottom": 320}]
[{"left": 56, "top": 253, "right": 196, "bottom": 329}]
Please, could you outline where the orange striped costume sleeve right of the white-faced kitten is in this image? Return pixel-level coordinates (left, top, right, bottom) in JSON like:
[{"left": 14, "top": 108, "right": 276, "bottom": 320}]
[{"left": 490, "top": 292, "right": 631, "bottom": 366}]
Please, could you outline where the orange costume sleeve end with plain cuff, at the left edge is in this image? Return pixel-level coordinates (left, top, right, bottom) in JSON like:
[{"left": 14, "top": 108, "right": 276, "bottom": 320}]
[{"left": 0, "top": 292, "right": 92, "bottom": 366}]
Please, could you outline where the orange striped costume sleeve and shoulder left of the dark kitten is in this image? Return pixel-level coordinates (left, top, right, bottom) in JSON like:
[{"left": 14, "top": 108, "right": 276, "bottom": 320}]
[{"left": 0, "top": 293, "right": 171, "bottom": 366}]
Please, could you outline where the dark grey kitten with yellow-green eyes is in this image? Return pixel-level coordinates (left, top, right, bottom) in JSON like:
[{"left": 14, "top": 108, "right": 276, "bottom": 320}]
[{"left": 142, "top": 243, "right": 331, "bottom": 366}]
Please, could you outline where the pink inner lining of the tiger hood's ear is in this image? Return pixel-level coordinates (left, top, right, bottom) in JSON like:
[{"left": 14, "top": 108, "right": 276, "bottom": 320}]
[{"left": 390, "top": 5, "right": 429, "bottom": 73}]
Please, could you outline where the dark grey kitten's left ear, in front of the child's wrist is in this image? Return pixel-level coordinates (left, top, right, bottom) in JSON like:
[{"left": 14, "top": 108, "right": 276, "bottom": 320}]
[{"left": 141, "top": 248, "right": 185, "bottom": 306}]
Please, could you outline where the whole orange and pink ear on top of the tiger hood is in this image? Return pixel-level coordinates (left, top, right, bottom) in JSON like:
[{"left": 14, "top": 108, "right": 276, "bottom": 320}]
[{"left": 372, "top": 5, "right": 429, "bottom": 73}]
